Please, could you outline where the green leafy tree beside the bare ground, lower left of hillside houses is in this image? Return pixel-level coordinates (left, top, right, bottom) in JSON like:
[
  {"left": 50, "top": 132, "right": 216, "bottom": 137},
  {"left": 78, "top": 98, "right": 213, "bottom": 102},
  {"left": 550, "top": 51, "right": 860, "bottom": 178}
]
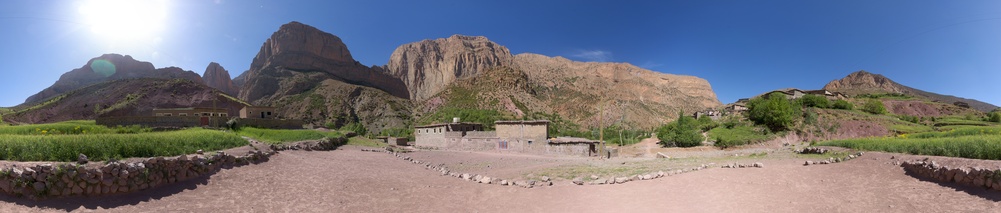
[{"left": 657, "top": 111, "right": 703, "bottom": 147}]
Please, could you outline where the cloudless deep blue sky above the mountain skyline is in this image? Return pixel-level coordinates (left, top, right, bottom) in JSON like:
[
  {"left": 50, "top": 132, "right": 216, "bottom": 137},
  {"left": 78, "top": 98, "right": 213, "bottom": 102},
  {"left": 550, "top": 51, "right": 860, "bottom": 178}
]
[{"left": 0, "top": 0, "right": 1001, "bottom": 106}]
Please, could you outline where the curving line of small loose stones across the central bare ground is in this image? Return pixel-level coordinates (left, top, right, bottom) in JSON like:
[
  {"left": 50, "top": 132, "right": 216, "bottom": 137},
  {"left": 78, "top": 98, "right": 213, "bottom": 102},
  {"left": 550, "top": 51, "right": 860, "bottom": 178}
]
[{"left": 361, "top": 148, "right": 740, "bottom": 188}]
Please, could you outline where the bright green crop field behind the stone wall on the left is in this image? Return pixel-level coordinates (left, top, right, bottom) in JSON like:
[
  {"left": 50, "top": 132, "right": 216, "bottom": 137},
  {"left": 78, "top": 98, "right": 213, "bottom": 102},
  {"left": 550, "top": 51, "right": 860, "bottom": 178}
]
[{"left": 0, "top": 121, "right": 247, "bottom": 161}]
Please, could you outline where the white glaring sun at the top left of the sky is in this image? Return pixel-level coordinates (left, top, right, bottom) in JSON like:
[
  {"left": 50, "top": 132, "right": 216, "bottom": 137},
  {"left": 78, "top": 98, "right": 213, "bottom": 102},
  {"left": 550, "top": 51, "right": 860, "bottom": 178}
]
[{"left": 79, "top": 0, "right": 167, "bottom": 42}]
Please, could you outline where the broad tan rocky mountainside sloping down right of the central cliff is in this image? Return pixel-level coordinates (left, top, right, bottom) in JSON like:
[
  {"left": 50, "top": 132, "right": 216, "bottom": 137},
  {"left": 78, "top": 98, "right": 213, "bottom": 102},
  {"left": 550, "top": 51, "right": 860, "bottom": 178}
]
[{"left": 514, "top": 53, "right": 722, "bottom": 128}]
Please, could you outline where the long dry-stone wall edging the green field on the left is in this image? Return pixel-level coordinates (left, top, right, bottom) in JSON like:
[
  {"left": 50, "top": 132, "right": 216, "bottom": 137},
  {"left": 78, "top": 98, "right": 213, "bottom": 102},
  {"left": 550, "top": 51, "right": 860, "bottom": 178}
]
[{"left": 0, "top": 138, "right": 347, "bottom": 200}]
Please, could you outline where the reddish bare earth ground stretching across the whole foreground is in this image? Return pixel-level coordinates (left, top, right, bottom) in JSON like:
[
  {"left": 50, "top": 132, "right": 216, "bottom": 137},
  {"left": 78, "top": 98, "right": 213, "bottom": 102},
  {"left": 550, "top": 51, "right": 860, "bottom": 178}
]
[{"left": 0, "top": 146, "right": 1001, "bottom": 212}]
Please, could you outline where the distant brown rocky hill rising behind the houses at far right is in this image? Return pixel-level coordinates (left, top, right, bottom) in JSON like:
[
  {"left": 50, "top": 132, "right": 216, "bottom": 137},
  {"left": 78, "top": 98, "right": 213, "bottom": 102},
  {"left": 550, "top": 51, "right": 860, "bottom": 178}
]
[{"left": 824, "top": 70, "right": 998, "bottom": 112}]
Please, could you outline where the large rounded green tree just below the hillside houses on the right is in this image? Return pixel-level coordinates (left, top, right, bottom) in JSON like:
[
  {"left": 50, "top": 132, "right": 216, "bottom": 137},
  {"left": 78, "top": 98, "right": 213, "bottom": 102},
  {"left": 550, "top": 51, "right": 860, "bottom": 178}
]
[{"left": 748, "top": 95, "right": 799, "bottom": 131}]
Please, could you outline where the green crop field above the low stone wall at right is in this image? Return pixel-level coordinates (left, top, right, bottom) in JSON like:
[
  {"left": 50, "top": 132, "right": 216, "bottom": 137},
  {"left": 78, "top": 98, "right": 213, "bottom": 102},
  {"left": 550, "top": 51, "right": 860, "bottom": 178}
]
[{"left": 817, "top": 127, "right": 1001, "bottom": 160}]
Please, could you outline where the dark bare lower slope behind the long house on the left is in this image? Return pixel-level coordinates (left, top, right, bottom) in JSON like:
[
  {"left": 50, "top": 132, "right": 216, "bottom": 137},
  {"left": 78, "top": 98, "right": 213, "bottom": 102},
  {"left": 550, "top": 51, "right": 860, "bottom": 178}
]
[{"left": 3, "top": 78, "right": 245, "bottom": 123}]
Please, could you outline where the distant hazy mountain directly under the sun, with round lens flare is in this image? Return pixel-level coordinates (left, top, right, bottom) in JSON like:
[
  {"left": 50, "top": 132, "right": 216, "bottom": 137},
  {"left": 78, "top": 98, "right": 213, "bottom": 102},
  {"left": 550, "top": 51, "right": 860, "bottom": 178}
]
[{"left": 24, "top": 54, "right": 204, "bottom": 104}]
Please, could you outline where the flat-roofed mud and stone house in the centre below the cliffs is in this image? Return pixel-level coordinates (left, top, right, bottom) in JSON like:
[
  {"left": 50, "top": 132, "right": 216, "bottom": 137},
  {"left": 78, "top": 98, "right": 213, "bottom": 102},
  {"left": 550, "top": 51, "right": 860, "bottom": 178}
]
[{"left": 414, "top": 120, "right": 598, "bottom": 156}]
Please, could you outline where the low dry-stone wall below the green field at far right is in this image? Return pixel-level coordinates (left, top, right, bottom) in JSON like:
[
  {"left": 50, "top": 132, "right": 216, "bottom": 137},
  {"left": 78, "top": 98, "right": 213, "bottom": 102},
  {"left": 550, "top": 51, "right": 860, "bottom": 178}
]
[{"left": 900, "top": 160, "right": 1001, "bottom": 191}]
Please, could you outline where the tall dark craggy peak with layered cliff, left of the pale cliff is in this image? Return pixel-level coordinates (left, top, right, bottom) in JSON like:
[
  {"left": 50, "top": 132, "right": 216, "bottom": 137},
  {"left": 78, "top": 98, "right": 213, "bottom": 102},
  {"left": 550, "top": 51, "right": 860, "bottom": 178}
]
[{"left": 234, "top": 22, "right": 410, "bottom": 133}]
